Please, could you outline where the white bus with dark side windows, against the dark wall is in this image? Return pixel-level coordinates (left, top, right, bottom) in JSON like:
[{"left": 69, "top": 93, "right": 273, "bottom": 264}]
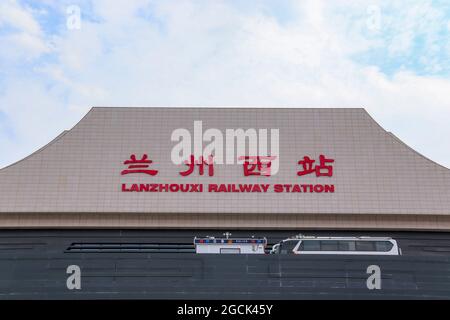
[{"left": 270, "top": 235, "right": 401, "bottom": 256}]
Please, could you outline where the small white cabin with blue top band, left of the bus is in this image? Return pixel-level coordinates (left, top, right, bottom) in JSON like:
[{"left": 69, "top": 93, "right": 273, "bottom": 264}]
[{"left": 194, "top": 233, "right": 267, "bottom": 254}]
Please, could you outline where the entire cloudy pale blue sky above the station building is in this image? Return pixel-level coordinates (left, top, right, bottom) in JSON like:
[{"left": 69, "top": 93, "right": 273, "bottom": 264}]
[{"left": 0, "top": 0, "right": 450, "bottom": 168}]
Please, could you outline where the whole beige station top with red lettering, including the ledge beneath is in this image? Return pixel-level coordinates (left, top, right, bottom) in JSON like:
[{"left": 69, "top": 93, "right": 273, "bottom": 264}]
[{"left": 0, "top": 107, "right": 450, "bottom": 231}]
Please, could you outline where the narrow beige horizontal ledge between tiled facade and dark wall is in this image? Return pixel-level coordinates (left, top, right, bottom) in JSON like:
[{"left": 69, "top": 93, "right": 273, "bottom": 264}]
[{"left": 0, "top": 213, "right": 450, "bottom": 231}]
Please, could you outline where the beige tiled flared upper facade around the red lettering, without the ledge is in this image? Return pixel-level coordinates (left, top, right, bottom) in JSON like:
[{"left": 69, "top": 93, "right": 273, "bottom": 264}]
[{"left": 0, "top": 107, "right": 450, "bottom": 215}]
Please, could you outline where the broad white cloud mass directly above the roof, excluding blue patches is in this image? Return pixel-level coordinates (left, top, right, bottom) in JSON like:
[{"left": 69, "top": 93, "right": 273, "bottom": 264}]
[{"left": 0, "top": 0, "right": 450, "bottom": 166}]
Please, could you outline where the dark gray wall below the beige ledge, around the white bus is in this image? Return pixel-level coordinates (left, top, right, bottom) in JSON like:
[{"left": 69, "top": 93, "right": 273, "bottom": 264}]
[{"left": 0, "top": 230, "right": 450, "bottom": 299}]
